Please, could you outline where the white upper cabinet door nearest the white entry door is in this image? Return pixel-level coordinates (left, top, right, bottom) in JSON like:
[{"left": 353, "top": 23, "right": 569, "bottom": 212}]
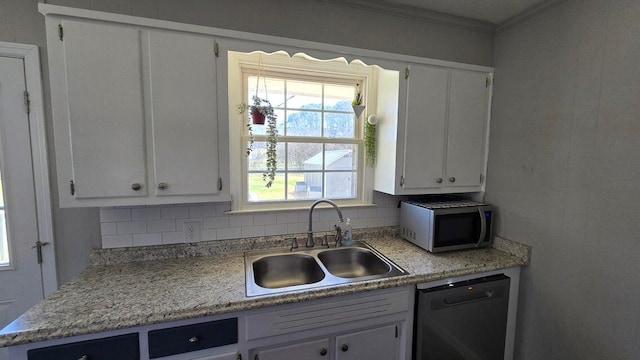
[{"left": 59, "top": 20, "right": 147, "bottom": 199}]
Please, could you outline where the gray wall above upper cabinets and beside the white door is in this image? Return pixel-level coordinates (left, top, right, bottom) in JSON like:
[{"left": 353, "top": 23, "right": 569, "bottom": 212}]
[{"left": 0, "top": 0, "right": 493, "bottom": 283}]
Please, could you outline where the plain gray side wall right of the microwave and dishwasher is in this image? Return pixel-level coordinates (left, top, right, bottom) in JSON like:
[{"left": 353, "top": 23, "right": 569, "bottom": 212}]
[{"left": 487, "top": 0, "right": 640, "bottom": 360}]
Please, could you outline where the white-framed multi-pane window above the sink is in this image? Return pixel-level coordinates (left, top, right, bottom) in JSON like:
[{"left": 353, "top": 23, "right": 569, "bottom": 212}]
[{"left": 229, "top": 49, "right": 372, "bottom": 209}]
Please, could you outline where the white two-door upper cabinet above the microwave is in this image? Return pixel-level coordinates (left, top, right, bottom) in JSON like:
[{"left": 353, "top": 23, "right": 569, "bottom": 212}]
[{"left": 374, "top": 64, "right": 491, "bottom": 195}]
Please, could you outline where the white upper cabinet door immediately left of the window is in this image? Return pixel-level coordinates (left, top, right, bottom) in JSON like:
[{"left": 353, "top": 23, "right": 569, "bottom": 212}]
[{"left": 149, "top": 31, "right": 219, "bottom": 196}]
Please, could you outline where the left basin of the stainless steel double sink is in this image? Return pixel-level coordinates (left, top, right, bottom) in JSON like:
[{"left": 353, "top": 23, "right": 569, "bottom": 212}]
[{"left": 252, "top": 254, "right": 324, "bottom": 289}]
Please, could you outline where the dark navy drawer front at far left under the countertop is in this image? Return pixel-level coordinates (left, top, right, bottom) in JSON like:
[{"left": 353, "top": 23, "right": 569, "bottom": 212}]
[{"left": 27, "top": 333, "right": 140, "bottom": 360}]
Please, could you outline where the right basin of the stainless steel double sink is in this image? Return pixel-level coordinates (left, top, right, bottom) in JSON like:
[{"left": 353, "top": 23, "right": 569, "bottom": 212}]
[{"left": 318, "top": 247, "right": 391, "bottom": 278}]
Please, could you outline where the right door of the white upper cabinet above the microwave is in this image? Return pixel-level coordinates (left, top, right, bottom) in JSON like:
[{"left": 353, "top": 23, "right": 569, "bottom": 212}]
[{"left": 445, "top": 71, "right": 489, "bottom": 187}]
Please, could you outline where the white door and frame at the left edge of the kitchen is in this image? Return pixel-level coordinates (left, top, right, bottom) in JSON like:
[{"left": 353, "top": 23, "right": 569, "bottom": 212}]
[{"left": 0, "top": 50, "right": 55, "bottom": 334}]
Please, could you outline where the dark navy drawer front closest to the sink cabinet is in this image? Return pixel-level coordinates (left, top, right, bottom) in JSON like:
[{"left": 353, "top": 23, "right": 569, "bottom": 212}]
[{"left": 149, "top": 318, "right": 238, "bottom": 359}]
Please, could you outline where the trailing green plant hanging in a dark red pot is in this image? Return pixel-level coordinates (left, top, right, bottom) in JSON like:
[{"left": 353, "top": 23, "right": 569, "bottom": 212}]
[{"left": 238, "top": 95, "right": 278, "bottom": 188}]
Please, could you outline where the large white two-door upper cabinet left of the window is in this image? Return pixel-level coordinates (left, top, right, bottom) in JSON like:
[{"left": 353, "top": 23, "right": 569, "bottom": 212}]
[{"left": 47, "top": 16, "right": 229, "bottom": 207}]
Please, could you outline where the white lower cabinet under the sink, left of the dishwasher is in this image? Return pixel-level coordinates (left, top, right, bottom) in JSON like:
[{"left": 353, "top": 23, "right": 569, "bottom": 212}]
[{"left": 245, "top": 286, "right": 415, "bottom": 360}]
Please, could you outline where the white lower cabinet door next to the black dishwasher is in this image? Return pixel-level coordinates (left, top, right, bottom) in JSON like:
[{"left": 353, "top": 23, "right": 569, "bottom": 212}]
[{"left": 335, "top": 325, "right": 400, "bottom": 360}]
